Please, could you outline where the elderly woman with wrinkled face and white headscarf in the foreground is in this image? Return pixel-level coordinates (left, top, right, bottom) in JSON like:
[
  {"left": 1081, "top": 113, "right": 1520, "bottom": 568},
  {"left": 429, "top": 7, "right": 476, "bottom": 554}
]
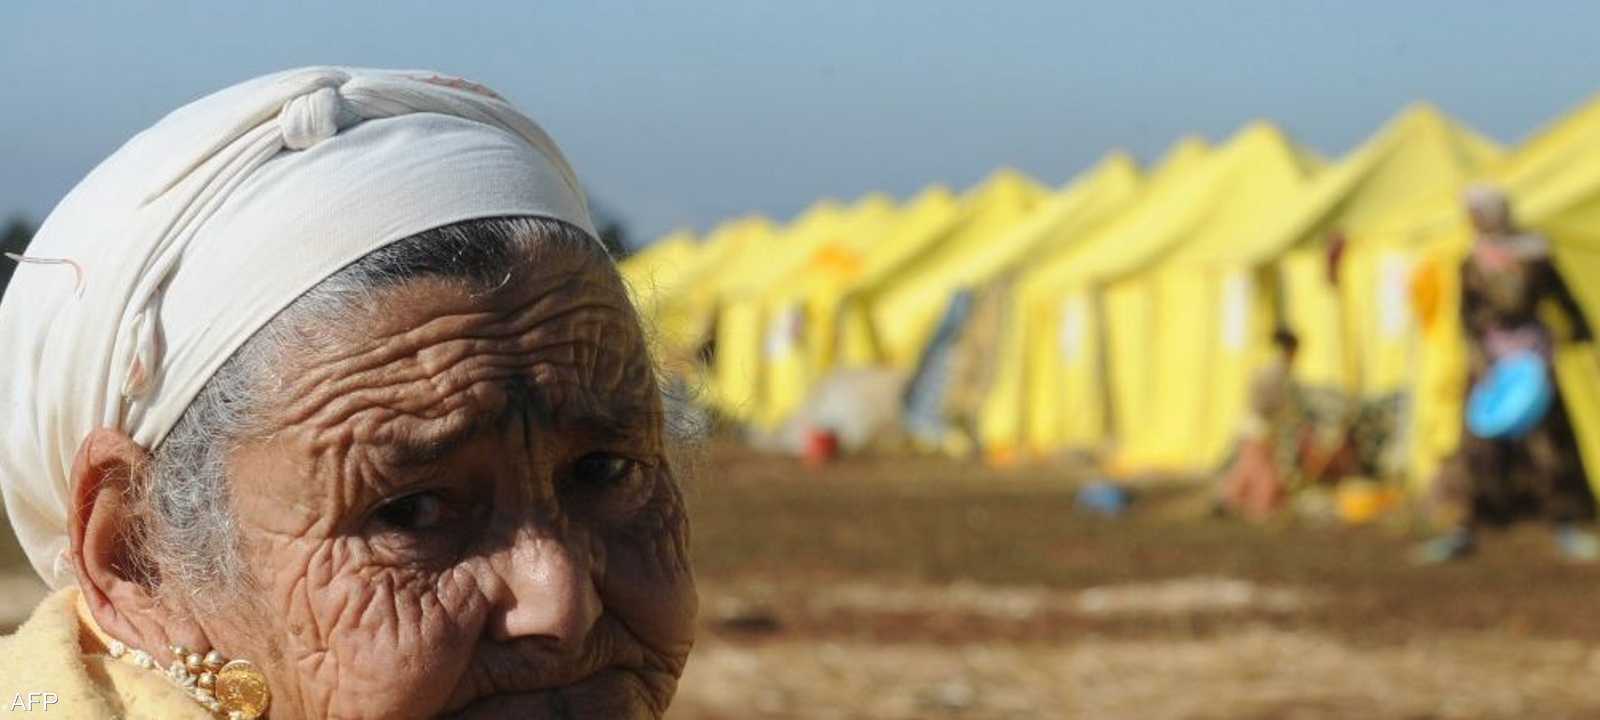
[{"left": 0, "top": 67, "right": 696, "bottom": 720}]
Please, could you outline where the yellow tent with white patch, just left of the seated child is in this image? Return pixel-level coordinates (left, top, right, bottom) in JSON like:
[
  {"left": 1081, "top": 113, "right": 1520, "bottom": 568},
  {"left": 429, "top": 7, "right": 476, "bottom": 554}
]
[{"left": 1106, "top": 123, "right": 1318, "bottom": 474}]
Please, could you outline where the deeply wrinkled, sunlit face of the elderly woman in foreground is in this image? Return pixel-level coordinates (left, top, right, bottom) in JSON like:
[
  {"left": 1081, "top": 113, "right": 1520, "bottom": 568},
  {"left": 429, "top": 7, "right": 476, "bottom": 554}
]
[{"left": 200, "top": 244, "right": 696, "bottom": 720}]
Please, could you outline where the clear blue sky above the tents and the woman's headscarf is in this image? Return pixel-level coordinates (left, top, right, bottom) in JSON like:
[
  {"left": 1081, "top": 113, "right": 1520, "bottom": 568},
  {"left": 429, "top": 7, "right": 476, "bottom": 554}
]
[{"left": 0, "top": 0, "right": 1600, "bottom": 246}]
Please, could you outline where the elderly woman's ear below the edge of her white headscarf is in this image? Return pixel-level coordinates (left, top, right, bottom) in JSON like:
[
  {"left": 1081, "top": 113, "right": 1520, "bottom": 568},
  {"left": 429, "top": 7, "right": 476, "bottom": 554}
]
[{"left": 67, "top": 427, "right": 208, "bottom": 658}]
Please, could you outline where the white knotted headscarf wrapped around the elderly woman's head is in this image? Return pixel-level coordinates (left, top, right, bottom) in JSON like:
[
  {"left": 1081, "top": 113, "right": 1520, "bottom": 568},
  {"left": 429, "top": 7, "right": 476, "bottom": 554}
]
[{"left": 0, "top": 67, "right": 594, "bottom": 587}]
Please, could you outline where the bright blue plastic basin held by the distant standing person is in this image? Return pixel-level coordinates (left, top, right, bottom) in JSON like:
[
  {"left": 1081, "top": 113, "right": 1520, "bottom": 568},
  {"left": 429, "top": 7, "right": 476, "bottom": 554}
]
[{"left": 1467, "top": 352, "right": 1555, "bottom": 440}]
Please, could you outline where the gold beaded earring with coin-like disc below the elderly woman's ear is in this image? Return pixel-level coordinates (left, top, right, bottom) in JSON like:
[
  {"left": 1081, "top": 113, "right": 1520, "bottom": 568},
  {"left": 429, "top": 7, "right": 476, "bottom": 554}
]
[{"left": 106, "top": 640, "right": 272, "bottom": 720}]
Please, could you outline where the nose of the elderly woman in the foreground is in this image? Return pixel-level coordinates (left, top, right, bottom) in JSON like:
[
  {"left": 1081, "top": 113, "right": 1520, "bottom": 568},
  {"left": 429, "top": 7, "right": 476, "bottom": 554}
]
[{"left": 490, "top": 533, "right": 600, "bottom": 653}]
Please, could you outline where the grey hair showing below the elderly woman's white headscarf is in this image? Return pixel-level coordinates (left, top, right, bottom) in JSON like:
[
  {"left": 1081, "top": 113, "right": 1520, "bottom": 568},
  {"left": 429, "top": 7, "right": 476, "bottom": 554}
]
[{"left": 134, "top": 218, "right": 605, "bottom": 602}]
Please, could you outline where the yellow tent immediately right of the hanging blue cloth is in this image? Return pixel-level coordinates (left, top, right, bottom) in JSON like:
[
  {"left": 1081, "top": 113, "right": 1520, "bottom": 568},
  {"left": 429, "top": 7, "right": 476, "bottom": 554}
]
[{"left": 981, "top": 138, "right": 1206, "bottom": 461}]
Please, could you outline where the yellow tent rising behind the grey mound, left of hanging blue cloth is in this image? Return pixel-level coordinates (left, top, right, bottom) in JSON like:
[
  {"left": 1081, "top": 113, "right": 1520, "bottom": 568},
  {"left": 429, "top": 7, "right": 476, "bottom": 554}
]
[{"left": 842, "top": 170, "right": 1045, "bottom": 370}]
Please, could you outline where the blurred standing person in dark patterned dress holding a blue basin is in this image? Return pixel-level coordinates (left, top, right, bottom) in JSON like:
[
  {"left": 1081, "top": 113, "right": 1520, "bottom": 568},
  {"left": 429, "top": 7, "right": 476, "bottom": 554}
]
[{"left": 1416, "top": 186, "right": 1600, "bottom": 563}]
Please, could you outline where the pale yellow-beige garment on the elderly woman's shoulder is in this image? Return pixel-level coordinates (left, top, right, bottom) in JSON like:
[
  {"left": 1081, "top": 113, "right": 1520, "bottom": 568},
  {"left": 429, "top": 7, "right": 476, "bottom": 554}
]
[{"left": 0, "top": 587, "right": 211, "bottom": 720}]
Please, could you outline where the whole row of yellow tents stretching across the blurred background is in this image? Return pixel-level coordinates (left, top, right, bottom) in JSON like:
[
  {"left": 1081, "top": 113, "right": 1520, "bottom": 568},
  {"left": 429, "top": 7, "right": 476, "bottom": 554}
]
[{"left": 622, "top": 101, "right": 1600, "bottom": 496}]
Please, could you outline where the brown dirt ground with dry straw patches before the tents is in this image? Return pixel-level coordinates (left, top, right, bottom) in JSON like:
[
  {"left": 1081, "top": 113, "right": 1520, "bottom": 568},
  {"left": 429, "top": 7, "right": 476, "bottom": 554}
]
[{"left": 9, "top": 445, "right": 1600, "bottom": 720}]
